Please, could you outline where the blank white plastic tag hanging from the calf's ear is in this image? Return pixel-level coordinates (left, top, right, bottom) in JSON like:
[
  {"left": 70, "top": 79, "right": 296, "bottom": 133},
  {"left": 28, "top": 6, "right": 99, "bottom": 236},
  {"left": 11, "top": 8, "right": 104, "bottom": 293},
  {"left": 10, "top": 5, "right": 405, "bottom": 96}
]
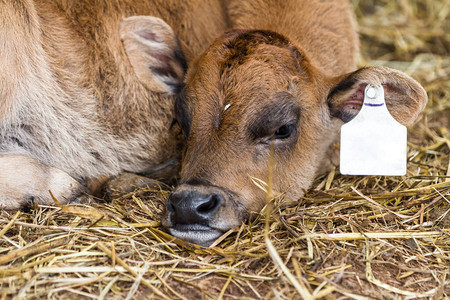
[{"left": 340, "top": 84, "right": 406, "bottom": 176}]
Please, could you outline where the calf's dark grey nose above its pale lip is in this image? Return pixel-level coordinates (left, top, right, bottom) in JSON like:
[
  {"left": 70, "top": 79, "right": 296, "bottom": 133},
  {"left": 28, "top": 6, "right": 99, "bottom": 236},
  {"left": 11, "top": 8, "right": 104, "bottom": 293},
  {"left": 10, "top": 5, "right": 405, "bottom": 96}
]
[{"left": 167, "top": 190, "right": 223, "bottom": 225}]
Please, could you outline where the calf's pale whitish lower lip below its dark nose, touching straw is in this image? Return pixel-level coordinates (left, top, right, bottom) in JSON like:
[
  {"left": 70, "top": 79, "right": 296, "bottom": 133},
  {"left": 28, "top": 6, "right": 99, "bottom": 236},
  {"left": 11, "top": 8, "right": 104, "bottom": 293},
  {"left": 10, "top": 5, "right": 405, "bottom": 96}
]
[{"left": 169, "top": 225, "right": 223, "bottom": 247}]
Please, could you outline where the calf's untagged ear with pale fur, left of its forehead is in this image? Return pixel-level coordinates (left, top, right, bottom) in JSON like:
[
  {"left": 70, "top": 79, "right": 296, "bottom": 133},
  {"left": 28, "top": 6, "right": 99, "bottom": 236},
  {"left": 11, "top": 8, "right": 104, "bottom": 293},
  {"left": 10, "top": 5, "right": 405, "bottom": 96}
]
[{"left": 119, "top": 16, "right": 187, "bottom": 95}]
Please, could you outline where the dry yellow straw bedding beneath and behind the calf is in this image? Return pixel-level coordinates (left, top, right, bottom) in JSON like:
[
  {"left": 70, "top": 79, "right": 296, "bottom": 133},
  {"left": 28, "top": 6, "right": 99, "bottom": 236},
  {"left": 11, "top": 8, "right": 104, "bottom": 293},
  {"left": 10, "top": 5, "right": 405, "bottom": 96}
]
[{"left": 0, "top": 0, "right": 450, "bottom": 299}]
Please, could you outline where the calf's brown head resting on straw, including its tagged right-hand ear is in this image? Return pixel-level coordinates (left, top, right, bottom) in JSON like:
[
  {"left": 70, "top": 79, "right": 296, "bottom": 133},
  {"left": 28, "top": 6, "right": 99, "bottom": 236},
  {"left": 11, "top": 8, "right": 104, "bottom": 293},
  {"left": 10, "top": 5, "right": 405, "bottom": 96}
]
[{"left": 163, "top": 30, "right": 427, "bottom": 245}]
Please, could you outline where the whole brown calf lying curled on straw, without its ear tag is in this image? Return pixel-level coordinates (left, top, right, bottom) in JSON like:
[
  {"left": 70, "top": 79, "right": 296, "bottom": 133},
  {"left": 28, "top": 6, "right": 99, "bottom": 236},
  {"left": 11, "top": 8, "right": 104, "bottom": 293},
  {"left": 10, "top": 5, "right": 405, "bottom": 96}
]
[{"left": 0, "top": 0, "right": 427, "bottom": 245}]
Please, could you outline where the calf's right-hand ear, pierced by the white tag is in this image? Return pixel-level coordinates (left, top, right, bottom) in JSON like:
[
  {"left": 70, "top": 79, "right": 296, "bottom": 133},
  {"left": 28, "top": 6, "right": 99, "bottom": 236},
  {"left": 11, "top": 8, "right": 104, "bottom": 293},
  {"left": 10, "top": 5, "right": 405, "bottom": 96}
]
[{"left": 327, "top": 67, "right": 428, "bottom": 125}]
